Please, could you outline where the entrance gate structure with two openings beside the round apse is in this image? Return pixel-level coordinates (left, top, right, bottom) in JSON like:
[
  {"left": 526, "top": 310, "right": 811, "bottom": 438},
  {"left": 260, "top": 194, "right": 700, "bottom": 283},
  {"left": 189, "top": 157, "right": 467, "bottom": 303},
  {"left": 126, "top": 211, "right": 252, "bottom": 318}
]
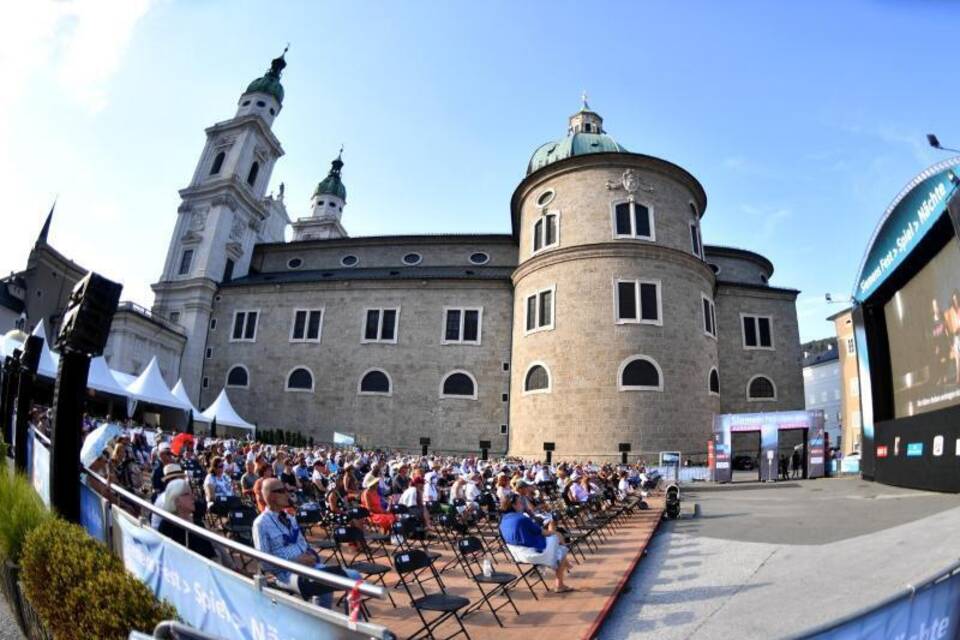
[{"left": 707, "top": 410, "right": 825, "bottom": 482}]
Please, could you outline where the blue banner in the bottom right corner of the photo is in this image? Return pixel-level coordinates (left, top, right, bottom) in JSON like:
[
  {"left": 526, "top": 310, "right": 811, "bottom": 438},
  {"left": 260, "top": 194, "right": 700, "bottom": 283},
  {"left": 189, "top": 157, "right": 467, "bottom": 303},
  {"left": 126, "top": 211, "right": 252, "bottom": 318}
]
[{"left": 807, "top": 574, "right": 960, "bottom": 640}]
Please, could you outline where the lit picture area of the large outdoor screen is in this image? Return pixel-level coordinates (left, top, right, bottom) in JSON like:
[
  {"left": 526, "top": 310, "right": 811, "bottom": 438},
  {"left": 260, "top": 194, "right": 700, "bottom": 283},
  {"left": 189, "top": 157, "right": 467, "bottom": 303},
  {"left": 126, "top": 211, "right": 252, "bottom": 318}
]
[{"left": 884, "top": 240, "right": 960, "bottom": 418}]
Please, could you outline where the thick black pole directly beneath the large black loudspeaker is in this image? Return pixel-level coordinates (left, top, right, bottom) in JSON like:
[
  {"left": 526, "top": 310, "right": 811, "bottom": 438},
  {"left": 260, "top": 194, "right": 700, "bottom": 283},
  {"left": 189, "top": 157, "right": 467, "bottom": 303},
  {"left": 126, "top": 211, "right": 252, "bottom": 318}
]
[{"left": 50, "top": 351, "right": 90, "bottom": 523}]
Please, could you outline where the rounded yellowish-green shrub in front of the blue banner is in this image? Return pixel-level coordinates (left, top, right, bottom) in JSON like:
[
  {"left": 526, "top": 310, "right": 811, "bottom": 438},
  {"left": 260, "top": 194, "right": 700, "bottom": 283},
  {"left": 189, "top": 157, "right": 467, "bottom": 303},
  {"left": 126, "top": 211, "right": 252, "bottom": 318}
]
[{"left": 21, "top": 519, "right": 176, "bottom": 640}]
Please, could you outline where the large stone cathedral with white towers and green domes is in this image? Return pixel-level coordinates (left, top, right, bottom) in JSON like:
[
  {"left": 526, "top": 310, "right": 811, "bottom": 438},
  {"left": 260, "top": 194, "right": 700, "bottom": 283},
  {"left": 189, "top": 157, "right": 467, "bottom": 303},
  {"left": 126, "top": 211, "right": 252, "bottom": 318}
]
[{"left": 0, "top": 51, "right": 803, "bottom": 460}]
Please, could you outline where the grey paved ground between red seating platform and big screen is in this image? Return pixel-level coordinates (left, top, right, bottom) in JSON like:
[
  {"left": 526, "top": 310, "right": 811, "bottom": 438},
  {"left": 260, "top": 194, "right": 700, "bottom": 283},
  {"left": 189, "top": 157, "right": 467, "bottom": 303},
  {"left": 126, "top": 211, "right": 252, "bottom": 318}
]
[{"left": 599, "top": 479, "right": 960, "bottom": 640}]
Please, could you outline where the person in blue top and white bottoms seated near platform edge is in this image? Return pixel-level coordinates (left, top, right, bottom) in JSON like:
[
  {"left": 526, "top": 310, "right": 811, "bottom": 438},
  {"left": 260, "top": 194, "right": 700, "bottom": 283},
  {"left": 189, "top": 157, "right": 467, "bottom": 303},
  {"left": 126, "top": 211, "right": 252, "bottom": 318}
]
[{"left": 500, "top": 493, "right": 573, "bottom": 593}]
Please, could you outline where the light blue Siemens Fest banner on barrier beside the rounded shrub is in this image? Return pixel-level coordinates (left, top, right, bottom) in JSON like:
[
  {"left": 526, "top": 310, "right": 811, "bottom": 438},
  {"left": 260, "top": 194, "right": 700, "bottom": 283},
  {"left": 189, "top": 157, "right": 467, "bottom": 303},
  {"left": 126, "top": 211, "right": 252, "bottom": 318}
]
[{"left": 112, "top": 509, "right": 369, "bottom": 640}]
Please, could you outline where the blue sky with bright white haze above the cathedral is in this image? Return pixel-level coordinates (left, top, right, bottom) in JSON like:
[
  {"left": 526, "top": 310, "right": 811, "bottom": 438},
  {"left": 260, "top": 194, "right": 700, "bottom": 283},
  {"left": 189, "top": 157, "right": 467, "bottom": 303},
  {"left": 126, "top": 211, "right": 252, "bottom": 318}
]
[{"left": 0, "top": 0, "right": 960, "bottom": 340}]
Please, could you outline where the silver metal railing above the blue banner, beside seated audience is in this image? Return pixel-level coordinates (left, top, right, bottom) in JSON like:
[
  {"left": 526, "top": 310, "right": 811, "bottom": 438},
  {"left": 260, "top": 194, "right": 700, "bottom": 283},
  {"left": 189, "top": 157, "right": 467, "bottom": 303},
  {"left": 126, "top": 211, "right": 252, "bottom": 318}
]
[{"left": 81, "top": 465, "right": 395, "bottom": 640}]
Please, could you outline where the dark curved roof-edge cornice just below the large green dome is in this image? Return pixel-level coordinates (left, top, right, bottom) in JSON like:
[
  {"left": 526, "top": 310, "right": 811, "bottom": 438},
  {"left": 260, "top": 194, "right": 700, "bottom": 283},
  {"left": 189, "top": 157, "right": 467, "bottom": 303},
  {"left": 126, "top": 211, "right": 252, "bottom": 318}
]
[{"left": 510, "top": 152, "right": 707, "bottom": 237}]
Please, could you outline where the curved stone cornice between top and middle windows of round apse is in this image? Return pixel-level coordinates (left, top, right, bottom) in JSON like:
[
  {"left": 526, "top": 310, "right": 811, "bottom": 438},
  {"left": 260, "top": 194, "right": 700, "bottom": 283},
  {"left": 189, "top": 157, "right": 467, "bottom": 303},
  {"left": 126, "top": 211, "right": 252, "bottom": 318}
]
[{"left": 513, "top": 241, "right": 716, "bottom": 286}]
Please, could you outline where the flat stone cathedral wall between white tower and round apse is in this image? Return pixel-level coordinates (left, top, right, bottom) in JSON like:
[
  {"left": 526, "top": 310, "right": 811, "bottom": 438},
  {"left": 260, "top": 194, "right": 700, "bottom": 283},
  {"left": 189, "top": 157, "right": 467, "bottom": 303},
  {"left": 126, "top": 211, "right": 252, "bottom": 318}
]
[{"left": 200, "top": 280, "right": 513, "bottom": 454}]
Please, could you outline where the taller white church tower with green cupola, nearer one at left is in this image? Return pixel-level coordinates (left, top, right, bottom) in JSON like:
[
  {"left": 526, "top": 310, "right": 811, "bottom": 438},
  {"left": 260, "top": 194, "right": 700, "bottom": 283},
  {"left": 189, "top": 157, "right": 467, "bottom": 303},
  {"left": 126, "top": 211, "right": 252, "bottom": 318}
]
[{"left": 152, "top": 50, "right": 290, "bottom": 402}]
